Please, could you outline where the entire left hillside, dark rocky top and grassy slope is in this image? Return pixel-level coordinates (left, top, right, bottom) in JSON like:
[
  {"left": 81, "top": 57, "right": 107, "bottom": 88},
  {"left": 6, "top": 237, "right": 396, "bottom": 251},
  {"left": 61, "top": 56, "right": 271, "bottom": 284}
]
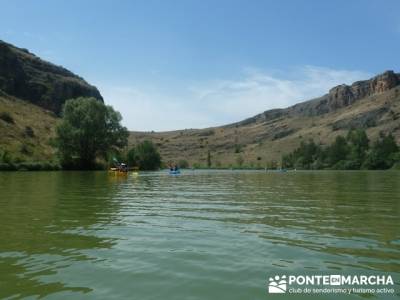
[{"left": 0, "top": 40, "right": 103, "bottom": 161}]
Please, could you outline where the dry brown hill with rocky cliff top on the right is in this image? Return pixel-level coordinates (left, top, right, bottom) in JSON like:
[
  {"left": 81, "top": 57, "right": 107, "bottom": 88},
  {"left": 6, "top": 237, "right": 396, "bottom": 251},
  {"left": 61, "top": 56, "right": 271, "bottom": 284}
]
[{"left": 130, "top": 71, "right": 400, "bottom": 167}]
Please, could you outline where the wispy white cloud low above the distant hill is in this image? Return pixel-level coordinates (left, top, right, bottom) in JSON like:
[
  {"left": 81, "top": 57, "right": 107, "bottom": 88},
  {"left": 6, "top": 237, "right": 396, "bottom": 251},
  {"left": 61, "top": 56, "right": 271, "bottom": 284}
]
[{"left": 97, "top": 66, "right": 371, "bottom": 131}]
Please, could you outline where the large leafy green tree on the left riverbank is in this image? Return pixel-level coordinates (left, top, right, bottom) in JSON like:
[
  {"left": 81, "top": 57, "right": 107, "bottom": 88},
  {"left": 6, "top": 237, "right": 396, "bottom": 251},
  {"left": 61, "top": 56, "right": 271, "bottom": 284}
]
[{"left": 56, "top": 97, "right": 129, "bottom": 169}]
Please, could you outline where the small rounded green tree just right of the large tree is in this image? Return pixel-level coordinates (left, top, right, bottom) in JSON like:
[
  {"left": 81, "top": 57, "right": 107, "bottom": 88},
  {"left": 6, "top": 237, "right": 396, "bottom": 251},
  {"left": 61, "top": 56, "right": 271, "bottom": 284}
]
[{"left": 135, "top": 140, "right": 161, "bottom": 171}]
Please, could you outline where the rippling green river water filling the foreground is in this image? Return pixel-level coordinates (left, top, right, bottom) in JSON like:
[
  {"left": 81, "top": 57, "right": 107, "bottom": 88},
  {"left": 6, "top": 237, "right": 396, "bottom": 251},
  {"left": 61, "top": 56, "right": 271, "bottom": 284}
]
[{"left": 0, "top": 171, "right": 400, "bottom": 300}]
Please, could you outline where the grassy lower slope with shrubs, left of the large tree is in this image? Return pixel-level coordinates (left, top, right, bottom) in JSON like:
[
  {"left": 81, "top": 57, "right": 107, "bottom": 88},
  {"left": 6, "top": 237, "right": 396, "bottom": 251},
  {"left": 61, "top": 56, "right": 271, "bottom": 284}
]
[{"left": 0, "top": 92, "right": 57, "bottom": 161}]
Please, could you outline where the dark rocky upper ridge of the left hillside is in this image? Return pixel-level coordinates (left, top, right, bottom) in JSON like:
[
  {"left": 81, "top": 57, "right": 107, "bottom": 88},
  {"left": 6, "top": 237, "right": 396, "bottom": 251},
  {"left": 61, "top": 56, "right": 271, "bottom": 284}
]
[{"left": 0, "top": 40, "right": 103, "bottom": 114}]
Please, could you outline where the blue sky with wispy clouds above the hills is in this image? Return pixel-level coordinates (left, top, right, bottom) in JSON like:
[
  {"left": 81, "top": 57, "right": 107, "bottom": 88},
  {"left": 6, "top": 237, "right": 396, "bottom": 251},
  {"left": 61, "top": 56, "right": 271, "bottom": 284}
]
[{"left": 0, "top": 0, "right": 400, "bottom": 130}]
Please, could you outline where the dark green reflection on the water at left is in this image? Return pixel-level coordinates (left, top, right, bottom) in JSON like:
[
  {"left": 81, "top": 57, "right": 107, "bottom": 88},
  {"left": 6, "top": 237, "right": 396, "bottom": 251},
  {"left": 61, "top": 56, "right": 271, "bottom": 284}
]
[{"left": 0, "top": 172, "right": 119, "bottom": 298}]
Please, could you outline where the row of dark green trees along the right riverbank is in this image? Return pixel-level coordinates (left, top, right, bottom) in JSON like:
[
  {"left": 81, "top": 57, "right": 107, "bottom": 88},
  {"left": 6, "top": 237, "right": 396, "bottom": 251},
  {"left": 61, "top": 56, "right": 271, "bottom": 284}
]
[{"left": 282, "top": 129, "right": 400, "bottom": 170}]
